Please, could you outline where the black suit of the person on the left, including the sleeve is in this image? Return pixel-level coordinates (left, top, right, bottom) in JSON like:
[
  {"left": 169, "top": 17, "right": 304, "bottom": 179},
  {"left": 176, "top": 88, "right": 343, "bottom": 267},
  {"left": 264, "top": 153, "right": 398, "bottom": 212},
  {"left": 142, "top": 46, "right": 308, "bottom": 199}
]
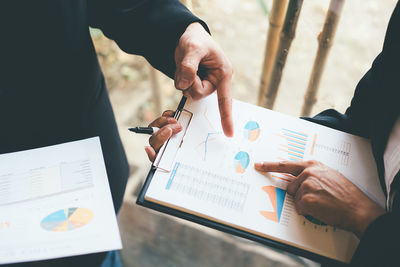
[{"left": 0, "top": 0, "right": 206, "bottom": 266}]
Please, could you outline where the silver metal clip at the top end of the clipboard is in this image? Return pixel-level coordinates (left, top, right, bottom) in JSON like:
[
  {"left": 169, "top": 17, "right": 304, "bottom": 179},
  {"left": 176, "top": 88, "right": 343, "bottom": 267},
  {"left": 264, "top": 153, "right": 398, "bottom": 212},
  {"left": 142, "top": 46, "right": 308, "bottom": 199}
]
[{"left": 153, "top": 96, "right": 193, "bottom": 172}]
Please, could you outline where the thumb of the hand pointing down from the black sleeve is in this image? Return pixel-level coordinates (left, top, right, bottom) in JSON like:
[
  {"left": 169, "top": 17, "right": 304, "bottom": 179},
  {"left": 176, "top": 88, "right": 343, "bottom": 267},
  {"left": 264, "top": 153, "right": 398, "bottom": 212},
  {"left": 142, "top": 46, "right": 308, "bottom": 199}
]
[{"left": 175, "top": 51, "right": 202, "bottom": 90}]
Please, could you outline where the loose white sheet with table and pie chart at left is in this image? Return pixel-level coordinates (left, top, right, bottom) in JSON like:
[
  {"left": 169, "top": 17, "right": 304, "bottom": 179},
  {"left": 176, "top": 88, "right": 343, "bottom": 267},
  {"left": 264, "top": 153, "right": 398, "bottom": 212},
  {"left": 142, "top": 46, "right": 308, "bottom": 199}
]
[{"left": 0, "top": 137, "right": 122, "bottom": 264}]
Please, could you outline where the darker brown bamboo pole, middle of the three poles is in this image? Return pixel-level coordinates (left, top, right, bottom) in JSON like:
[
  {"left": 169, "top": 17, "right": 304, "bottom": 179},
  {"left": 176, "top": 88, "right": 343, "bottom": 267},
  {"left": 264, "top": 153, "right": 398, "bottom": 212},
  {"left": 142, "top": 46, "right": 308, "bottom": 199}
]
[{"left": 262, "top": 0, "right": 303, "bottom": 109}]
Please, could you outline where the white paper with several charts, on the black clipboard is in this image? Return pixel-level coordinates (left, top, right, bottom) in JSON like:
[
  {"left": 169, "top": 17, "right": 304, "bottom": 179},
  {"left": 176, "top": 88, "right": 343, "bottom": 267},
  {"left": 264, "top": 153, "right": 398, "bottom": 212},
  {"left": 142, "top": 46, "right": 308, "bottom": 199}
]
[{"left": 145, "top": 94, "right": 385, "bottom": 262}]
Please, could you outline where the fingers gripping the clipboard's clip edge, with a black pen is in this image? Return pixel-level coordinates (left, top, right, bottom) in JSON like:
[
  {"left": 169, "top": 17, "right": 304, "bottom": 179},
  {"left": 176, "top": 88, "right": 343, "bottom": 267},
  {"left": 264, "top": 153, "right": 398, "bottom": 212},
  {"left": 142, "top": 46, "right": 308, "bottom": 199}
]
[{"left": 144, "top": 110, "right": 182, "bottom": 162}]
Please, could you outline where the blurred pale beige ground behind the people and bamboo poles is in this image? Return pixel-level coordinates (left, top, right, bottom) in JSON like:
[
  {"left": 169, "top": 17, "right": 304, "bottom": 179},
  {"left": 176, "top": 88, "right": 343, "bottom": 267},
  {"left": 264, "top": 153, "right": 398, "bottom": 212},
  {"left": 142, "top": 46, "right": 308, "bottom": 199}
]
[{"left": 93, "top": 0, "right": 396, "bottom": 266}]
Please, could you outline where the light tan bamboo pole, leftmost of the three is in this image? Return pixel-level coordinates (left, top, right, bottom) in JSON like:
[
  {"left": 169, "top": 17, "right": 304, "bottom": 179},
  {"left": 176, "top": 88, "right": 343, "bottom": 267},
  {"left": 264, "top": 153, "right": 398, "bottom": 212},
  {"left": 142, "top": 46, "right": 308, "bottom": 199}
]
[{"left": 258, "top": 0, "right": 288, "bottom": 105}]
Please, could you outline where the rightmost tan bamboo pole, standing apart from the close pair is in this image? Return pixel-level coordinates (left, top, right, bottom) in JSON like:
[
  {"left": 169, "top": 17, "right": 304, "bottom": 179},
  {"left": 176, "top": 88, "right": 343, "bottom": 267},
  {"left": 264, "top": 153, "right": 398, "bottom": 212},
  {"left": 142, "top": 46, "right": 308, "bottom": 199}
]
[{"left": 301, "top": 0, "right": 344, "bottom": 116}]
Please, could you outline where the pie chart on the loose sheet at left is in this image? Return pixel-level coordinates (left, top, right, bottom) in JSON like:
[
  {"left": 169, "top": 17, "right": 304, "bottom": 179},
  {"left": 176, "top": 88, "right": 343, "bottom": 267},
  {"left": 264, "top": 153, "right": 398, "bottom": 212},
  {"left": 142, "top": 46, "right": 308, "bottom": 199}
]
[{"left": 40, "top": 208, "right": 94, "bottom": 232}]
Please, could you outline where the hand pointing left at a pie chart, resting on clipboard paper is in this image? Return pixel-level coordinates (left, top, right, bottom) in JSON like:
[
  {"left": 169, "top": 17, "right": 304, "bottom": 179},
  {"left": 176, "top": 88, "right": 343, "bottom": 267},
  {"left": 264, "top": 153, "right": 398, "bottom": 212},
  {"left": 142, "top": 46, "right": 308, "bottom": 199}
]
[{"left": 255, "top": 161, "right": 385, "bottom": 237}]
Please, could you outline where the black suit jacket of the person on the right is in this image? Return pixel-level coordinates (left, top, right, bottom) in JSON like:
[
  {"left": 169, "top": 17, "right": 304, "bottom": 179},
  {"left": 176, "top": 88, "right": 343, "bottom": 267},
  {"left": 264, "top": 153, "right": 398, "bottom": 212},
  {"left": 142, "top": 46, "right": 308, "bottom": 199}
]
[{"left": 304, "top": 3, "right": 400, "bottom": 266}]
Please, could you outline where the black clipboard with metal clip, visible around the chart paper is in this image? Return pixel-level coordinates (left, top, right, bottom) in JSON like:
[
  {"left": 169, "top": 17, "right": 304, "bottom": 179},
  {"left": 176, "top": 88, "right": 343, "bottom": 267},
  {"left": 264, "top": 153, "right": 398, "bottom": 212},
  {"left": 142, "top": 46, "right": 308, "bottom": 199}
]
[{"left": 136, "top": 97, "right": 345, "bottom": 266}]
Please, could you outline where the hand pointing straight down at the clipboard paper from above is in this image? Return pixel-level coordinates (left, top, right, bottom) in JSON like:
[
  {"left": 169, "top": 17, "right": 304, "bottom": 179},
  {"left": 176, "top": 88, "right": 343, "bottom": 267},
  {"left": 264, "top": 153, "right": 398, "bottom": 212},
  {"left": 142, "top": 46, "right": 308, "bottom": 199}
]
[{"left": 175, "top": 22, "right": 233, "bottom": 136}]
